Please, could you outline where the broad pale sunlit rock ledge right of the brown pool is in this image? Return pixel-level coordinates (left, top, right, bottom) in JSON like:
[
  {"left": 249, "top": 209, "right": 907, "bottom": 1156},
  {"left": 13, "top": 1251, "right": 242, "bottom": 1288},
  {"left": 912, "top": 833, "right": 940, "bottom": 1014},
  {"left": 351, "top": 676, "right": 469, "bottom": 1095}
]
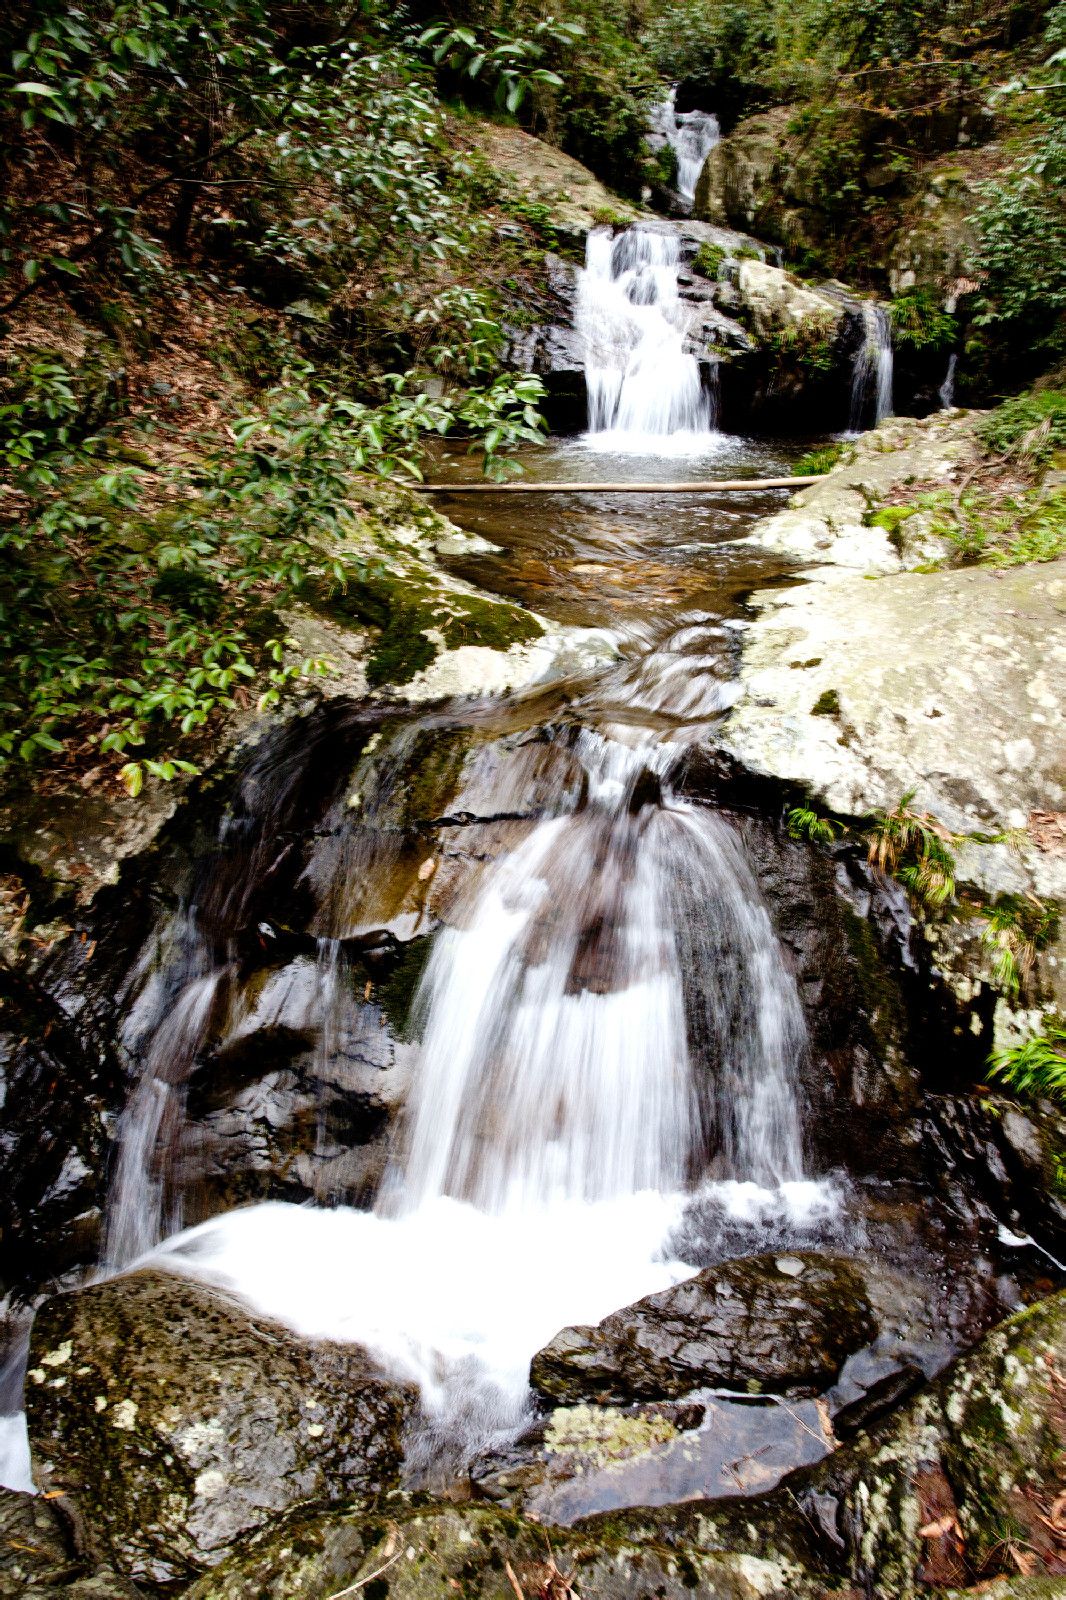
[{"left": 722, "top": 413, "right": 1066, "bottom": 1042}]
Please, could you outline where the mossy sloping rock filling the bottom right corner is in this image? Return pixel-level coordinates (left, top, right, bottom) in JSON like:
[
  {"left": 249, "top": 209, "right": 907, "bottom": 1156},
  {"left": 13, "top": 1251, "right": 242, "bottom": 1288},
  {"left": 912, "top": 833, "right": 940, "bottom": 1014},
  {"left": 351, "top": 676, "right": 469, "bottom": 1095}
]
[{"left": 579, "top": 1293, "right": 1066, "bottom": 1600}]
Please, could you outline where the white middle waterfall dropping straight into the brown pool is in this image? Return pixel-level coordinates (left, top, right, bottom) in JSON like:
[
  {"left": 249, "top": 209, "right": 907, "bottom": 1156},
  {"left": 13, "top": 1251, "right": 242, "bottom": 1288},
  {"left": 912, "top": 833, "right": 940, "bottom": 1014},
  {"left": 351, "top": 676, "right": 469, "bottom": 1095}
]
[{"left": 575, "top": 224, "right": 714, "bottom": 450}]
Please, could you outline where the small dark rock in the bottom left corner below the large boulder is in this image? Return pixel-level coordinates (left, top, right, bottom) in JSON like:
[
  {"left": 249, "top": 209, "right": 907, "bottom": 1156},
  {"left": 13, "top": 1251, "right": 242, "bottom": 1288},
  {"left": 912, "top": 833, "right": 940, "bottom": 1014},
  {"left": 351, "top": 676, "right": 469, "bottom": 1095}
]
[{"left": 0, "top": 1490, "right": 138, "bottom": 1600}]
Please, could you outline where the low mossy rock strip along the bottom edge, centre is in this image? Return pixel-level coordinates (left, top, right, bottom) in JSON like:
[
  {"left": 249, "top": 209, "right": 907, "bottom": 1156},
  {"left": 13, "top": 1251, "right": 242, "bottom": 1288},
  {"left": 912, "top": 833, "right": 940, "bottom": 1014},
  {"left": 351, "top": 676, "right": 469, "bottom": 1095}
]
[{"left": 186, "top": 1506, "right": 855, "bottom": 1600}]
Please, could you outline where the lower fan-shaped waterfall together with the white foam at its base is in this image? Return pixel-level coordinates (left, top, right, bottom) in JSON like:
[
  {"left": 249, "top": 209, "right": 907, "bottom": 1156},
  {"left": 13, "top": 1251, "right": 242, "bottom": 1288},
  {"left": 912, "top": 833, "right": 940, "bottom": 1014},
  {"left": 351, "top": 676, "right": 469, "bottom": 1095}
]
[{"left": 140, "top": 730, "right": 816, "bottom": 1448}]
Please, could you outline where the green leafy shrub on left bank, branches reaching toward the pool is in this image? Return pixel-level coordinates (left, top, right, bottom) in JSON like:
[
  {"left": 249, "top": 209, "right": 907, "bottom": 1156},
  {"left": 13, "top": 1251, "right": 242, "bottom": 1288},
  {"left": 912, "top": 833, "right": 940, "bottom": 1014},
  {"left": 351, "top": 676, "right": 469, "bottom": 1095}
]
[{"left": 0, "top": 342, "right": 541, "bottom": 780}]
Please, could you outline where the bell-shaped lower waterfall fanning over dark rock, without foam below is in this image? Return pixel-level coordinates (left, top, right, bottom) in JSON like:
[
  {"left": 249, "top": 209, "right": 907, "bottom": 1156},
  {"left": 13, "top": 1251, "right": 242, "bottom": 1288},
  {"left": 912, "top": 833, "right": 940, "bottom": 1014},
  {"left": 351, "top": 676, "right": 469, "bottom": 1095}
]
[{"left": 397, "top": 731, "right": 805, "bottom": 1211}]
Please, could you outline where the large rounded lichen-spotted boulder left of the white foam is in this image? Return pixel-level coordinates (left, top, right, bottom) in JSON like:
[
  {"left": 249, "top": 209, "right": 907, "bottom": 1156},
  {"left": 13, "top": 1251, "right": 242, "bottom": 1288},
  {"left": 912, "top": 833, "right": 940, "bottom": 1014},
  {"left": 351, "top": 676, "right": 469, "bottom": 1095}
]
[{"left": 27, "top": 1270, "right": 411, "bottom": 1582}]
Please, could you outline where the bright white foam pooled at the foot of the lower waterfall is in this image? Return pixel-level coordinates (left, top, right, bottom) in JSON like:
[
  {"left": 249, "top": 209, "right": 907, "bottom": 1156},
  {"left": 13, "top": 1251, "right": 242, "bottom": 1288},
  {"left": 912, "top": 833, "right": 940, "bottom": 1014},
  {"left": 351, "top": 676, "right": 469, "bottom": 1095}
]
[{"left": 147, "top": 1192, "right": 695, "bottom": 1426}]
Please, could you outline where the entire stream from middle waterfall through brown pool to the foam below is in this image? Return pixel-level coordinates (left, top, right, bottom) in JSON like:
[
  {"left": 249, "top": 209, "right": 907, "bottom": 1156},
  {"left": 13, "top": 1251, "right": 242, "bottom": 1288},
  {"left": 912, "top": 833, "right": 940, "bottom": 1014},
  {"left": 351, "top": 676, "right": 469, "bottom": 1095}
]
[{"left": 2, "top": 226, "right": 1024, "bottom": 1514}]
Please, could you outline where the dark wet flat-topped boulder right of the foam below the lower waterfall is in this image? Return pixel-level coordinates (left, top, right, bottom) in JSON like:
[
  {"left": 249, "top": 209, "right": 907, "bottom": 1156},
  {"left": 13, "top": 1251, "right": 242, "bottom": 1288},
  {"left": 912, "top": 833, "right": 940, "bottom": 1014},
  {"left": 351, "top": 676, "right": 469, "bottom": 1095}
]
[{"left": 530, "top": 1254, "right": 874, "bottom": 1403}]
